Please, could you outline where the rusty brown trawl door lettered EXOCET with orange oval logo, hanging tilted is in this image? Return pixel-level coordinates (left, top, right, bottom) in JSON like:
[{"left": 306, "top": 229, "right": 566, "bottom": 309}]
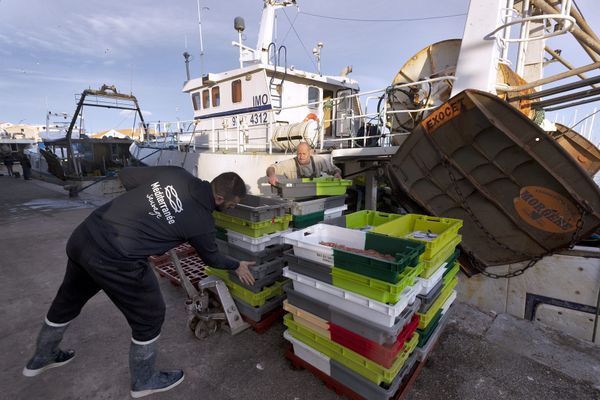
[{"left": 386, "top": 90, "right": 600, "bottom": 270}]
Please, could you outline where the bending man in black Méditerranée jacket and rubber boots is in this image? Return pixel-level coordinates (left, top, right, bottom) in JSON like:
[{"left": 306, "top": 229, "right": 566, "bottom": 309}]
[{"left": 23, "top": 167, "right": 254, "bottom": 398}]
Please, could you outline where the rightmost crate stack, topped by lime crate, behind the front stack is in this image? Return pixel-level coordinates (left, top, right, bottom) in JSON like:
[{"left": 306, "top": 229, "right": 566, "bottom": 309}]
[{"left": 371, "top": 214, "right": 463, "bottom": 360}]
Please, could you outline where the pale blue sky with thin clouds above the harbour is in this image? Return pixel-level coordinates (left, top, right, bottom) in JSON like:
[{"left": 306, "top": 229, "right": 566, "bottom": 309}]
[{"left": 0, "top": 0, "right": 600, "bottom": 144}]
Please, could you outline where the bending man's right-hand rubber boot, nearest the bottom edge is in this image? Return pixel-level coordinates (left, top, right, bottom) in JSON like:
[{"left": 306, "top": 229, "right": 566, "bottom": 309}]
[{"left": 129, "top": 342, "right": 185, "bottom": 398}]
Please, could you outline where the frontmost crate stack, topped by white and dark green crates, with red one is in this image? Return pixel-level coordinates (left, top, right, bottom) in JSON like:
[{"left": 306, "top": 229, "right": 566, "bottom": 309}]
[{"left": 284, "top": 224, "right": 424, "bottom": 400}]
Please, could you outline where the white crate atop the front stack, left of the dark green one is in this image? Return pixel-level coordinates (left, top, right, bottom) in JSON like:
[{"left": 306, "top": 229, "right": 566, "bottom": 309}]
[{"left": 283, "top": 224, "right": 366, "bottom": 266}]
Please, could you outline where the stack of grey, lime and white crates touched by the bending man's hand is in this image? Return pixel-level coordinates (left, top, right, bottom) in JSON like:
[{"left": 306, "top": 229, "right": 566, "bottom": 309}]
[{"left": 206, "top": 195, "right": 291, "bottom": 323}]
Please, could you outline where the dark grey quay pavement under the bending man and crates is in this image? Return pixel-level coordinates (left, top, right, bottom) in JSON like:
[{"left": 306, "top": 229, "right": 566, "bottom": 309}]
[{"left": 0, "top": 169, "right": 600, "bottom": 400}]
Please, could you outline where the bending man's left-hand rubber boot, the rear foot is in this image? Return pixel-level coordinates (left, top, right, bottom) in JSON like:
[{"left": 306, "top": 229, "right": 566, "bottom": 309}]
[{"left": 23, "top": 319, "right": 75, "bottom": 376}]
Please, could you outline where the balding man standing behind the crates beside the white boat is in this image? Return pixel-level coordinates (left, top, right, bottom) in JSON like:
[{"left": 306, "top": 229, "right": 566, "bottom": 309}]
[{"left": 267, "top": 142, "right": 342, "bottom": 185}]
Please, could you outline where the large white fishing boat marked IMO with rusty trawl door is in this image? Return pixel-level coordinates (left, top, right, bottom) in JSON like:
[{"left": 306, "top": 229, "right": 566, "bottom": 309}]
[{"left": 130, "top": 0, "right": 600, "bottom": 340}]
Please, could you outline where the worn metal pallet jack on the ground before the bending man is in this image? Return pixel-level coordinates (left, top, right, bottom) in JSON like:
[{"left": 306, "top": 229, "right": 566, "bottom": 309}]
[{"left": 169, "top": 250, "right": 250, "bottom": 339}]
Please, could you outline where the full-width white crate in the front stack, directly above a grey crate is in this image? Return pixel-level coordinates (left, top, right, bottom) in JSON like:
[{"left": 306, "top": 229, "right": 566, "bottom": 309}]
[{"left": 283, "top": 267, "right": 421, "bottom": 327}]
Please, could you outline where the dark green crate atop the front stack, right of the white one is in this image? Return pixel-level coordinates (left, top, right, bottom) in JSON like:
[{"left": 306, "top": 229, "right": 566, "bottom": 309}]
[{"left": 333, "top": 232, "right": 425, "bottom": 283}]
